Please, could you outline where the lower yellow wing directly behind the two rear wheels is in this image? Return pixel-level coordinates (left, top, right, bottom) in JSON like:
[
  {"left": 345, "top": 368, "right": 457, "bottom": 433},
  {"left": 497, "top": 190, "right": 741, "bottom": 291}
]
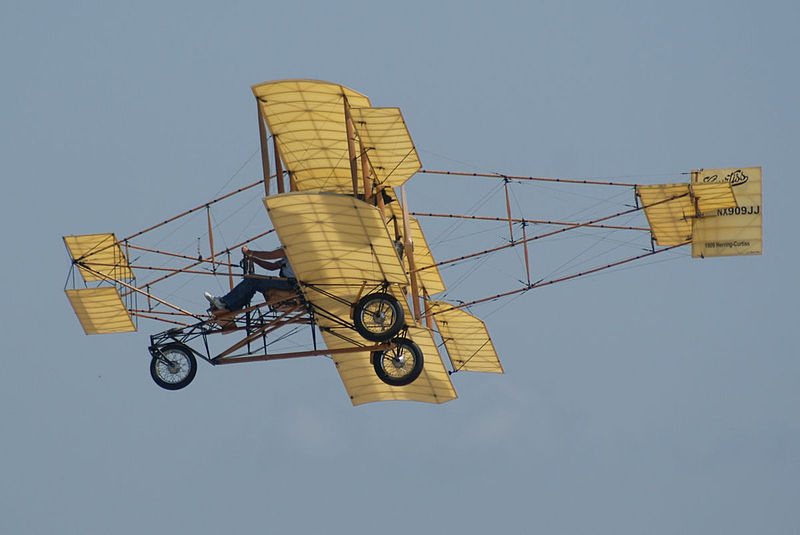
[{"left": 264, "top": 192, "right": 456, "bottom": 405}]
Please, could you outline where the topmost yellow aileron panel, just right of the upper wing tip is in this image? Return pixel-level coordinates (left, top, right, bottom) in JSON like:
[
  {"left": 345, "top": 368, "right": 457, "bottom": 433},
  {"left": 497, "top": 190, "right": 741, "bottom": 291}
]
[{"left": 350, "top": 108, "right": 422, "bottom": 188}]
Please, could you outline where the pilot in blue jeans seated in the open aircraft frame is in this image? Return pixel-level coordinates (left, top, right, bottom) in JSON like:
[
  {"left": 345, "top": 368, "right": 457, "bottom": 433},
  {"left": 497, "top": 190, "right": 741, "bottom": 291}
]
[{"left": 205, "top": 245, "right": 295, "bottom": 311}]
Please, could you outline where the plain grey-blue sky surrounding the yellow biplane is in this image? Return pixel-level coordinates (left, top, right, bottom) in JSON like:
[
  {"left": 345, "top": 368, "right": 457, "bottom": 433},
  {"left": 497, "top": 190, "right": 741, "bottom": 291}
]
[{"left": 0, "top": 2, "right": 800, "bottom": 533}]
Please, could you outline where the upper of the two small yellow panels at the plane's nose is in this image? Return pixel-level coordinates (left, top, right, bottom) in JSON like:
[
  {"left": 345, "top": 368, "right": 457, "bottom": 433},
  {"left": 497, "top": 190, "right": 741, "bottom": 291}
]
[{"left": 64, "top": 234, "right": 134, "bottom": 282}]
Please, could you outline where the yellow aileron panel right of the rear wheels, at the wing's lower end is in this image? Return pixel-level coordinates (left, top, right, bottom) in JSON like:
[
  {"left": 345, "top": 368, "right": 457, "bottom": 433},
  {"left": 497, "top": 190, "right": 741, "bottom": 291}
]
[{"left": 428, "top": 301, "right": 503, "bottom": 373}]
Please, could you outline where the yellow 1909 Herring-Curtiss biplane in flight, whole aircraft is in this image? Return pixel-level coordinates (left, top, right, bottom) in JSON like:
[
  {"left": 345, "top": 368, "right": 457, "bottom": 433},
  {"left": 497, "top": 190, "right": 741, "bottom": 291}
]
[{"left": 64, "top": 80, "right": 762, "bottom": 405}]
